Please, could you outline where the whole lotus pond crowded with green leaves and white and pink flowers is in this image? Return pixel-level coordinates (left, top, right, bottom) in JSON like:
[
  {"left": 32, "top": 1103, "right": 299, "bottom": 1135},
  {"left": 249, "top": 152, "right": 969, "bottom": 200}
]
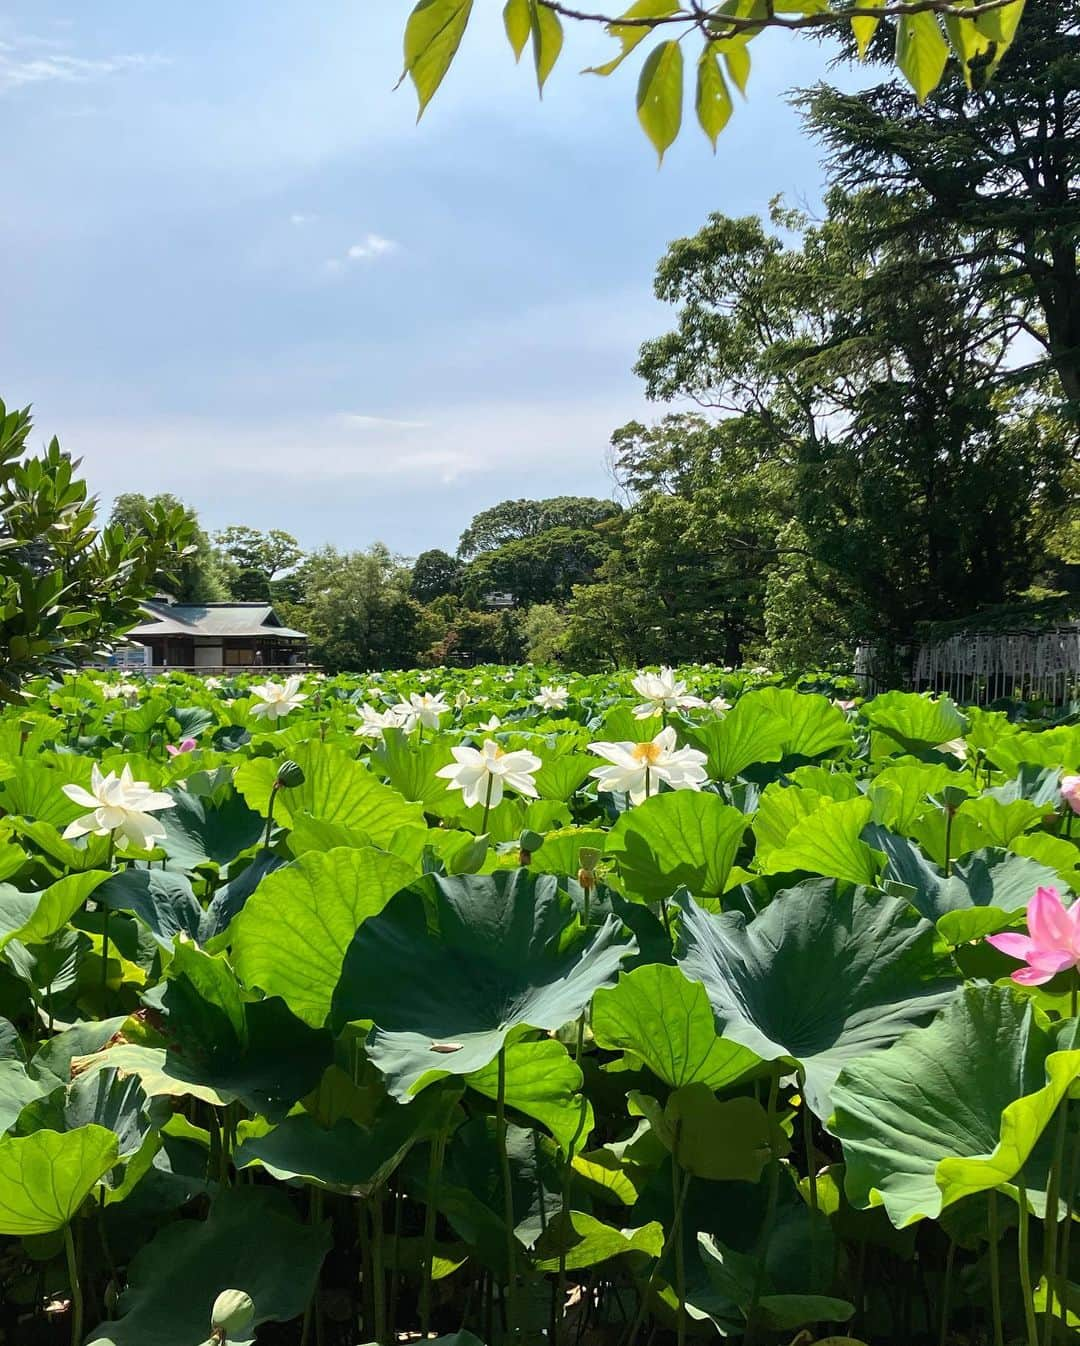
[{"left": 0, "top": 668, "right": 1080, "bottom": 1346}]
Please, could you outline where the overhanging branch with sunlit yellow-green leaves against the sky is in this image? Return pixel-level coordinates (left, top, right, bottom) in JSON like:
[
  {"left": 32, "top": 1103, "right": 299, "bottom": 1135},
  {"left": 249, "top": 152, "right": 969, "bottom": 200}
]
[{"left": 395, "top": 0, "right": 1026, "bottom": 159}]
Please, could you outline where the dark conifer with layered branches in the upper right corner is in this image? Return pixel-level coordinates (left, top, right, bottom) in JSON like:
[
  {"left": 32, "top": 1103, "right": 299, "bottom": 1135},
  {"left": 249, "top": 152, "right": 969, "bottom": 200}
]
[{"left": 800, "top": 0, "right": 1080, "bottom": 420}]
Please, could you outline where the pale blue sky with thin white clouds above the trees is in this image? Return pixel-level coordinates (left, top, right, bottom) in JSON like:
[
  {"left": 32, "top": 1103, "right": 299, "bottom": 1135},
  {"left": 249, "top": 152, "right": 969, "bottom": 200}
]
[{"left": 0, "top": 0, "right": 856, "bottom": 555}]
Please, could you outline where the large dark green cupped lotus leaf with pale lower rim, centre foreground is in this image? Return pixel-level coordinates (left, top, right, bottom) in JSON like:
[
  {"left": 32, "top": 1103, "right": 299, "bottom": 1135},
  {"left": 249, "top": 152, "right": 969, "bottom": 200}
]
[{"left": 333, "top": 870, "right": 636, "bottom": 1098}]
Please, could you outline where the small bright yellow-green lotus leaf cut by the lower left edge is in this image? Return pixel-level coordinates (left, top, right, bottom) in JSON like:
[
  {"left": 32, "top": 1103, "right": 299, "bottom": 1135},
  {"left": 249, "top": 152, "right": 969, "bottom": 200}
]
[{"left": 0, "top": 1127, "right": 117, "bottom": 1236}]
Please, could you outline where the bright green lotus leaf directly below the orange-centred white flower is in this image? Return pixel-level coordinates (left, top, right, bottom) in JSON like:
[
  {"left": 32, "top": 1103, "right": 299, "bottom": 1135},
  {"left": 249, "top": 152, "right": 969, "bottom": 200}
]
[{"left": 607, "top": 790, "right": 746, "bottom": 900}]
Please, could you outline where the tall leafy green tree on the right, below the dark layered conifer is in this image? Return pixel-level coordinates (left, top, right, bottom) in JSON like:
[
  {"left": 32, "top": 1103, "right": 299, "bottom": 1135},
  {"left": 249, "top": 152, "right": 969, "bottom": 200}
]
[{"left": 626, "top": 191, "right": 1076, "bottom": 654}]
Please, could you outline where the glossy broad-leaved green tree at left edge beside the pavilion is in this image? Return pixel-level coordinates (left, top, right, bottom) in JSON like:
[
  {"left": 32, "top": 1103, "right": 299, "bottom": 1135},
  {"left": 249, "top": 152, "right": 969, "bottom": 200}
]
[{"left": 0, "top": 402, "right": 191, "bottom": 701}]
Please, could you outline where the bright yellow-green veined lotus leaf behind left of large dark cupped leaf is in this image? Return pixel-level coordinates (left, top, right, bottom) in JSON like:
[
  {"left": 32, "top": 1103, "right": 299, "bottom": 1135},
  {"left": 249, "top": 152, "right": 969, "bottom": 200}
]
[{"left": 230, "top": 847, "right": 416, "bottom": 1028}]
